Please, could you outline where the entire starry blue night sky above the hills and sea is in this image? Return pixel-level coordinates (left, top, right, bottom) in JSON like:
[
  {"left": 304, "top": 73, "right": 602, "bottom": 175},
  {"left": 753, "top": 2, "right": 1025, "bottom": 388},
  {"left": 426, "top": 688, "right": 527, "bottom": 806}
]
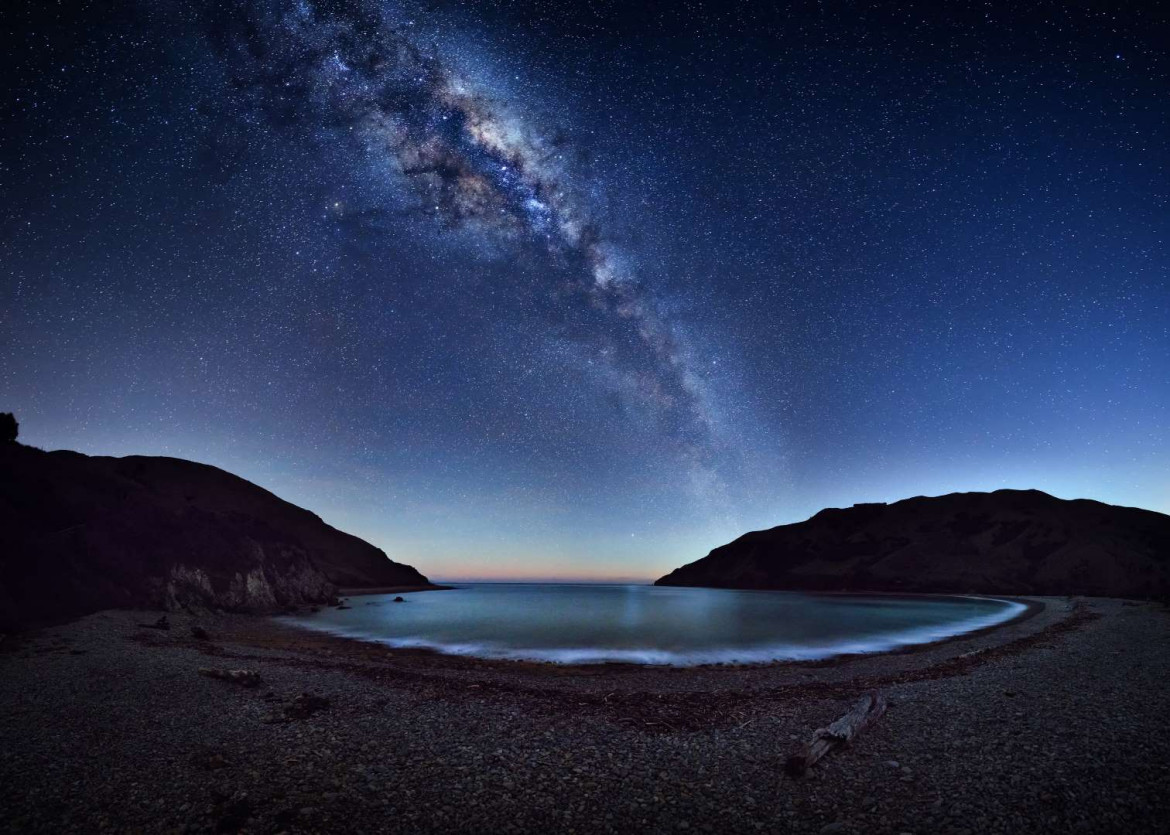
[{"left": 0, "top": 0, "right": 1170, "bottom": 579}]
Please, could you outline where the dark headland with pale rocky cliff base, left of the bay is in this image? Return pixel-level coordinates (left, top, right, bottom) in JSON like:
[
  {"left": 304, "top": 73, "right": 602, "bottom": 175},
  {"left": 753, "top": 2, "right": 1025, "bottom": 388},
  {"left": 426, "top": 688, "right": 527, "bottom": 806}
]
[{"left": 0, "top": 443, "right": 429, "bottom": 626}]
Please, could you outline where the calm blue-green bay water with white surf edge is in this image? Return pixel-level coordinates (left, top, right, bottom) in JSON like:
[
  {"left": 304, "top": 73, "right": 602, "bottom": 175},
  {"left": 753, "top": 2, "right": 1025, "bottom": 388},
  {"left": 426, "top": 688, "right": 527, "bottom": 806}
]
[{"left": 287, "top": 584, "right": 1024, "bottom": 665}]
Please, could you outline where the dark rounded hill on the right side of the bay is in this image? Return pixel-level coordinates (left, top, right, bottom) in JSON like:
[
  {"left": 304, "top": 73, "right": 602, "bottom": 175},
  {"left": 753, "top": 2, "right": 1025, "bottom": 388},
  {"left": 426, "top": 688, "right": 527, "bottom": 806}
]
[{"left": 656, "top": 490, "right": 1170, "bottom": 598}]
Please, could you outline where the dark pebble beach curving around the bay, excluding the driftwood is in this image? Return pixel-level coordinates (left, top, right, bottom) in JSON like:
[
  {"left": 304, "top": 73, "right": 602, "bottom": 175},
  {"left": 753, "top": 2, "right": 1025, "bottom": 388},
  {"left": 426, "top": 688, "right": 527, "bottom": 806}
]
[{"left": 0, "top": 598, "right": 1170, "bottom": 833}]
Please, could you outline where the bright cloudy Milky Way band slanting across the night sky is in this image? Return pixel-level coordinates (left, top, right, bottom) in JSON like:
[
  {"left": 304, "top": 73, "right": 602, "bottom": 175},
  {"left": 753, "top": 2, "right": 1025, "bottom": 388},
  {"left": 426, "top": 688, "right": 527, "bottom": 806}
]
[{"left": 215, "top": 0, "right": 721, "bottom": 484}]
